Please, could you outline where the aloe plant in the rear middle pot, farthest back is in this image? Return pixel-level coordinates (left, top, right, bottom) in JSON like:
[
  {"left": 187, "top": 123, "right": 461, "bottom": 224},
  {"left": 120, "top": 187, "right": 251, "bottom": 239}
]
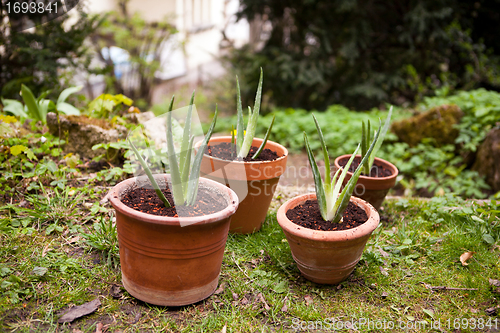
[{"left": 232, "top": 68, "right": 274, "bottom": 160}]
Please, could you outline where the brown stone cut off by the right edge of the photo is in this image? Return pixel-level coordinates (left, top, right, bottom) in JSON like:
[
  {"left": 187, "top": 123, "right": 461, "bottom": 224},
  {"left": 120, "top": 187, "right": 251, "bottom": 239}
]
[{"left": 472, "top": 126, "right": 500, "bottom": 192}]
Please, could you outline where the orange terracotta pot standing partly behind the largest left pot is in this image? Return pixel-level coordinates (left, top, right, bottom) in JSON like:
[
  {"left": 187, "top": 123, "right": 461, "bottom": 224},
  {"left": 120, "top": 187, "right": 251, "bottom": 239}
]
[{"left": 196, "top": 136, "right": 288, "bottom": 234}]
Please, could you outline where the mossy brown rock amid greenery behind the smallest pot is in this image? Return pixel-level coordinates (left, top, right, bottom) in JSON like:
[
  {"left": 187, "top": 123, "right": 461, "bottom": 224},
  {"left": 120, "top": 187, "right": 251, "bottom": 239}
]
[{"left": 391, "top": 105, "right": 463, "bottom": 147}]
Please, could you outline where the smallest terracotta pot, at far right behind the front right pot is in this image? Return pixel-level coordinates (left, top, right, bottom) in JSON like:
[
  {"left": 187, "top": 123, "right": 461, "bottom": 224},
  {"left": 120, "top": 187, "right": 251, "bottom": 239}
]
[{"left": 334, "top": 155, "right": 399, "bottom": 210}]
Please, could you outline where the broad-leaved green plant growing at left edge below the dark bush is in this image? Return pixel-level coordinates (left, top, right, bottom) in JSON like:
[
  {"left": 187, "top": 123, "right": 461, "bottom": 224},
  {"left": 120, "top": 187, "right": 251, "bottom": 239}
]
[{"left": 2, "top": 84, "right": 82, "bottom": 123}]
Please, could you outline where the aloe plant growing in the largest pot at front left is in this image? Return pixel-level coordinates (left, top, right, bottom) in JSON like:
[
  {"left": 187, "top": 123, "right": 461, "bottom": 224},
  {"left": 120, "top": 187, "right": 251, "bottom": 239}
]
[{"left": 128, "top": 93, "right": 218, "bottom": 207}]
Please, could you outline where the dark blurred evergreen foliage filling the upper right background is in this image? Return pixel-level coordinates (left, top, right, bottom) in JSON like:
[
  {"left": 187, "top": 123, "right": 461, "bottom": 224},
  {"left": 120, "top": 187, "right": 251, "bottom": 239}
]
[{"left": 232, "top": 0, "right": 500, "bottom": 110}]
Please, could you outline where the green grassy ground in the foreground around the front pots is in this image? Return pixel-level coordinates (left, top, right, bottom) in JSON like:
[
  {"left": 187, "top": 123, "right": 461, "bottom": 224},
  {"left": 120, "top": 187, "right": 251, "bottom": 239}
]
[{"left": 0, "top": 187, "right": 500, "bottom": 332}]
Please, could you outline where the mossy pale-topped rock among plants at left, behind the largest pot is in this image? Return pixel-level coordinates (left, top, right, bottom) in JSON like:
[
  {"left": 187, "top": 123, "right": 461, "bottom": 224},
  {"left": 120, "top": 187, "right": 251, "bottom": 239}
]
[{"left": 47, "top": 112, "right": 127, "bottom": 159}]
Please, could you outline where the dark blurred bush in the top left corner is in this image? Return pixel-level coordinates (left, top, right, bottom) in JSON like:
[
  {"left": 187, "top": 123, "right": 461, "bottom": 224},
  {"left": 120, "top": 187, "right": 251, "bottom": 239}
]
[{"left": 0, "top": 4, "right": 101, "bottom": 99}]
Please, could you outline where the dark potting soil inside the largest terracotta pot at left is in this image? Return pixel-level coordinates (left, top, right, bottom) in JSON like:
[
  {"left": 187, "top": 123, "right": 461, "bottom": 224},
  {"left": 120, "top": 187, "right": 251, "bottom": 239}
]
[{"left": 121, "top": 187, "right": 227, "bottom": 217}]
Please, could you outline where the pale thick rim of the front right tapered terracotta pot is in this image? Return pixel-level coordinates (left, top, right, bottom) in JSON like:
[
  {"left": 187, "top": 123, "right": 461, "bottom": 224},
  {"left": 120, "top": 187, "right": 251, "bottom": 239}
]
[{"left": 277, "top": 193, "right": 380, "bottom": 242}]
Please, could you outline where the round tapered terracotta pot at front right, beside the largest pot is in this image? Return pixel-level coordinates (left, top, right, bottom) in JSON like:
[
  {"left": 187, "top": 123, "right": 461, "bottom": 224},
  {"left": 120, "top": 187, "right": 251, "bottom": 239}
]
[{"left": 277, "top": 193, "right": 380, "bottom": 284}]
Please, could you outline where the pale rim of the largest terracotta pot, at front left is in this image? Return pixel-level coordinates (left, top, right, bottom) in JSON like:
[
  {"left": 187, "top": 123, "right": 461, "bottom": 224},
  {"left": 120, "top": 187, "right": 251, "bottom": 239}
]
[{"left": 106, "top": 174, "right": 239, "bottom": 226}]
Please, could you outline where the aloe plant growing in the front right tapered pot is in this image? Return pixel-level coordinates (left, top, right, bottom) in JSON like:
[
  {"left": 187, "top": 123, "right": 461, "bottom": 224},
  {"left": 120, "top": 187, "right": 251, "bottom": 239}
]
[{"left": 304, "top": 115, "right": 381, "bottom": 223}]
